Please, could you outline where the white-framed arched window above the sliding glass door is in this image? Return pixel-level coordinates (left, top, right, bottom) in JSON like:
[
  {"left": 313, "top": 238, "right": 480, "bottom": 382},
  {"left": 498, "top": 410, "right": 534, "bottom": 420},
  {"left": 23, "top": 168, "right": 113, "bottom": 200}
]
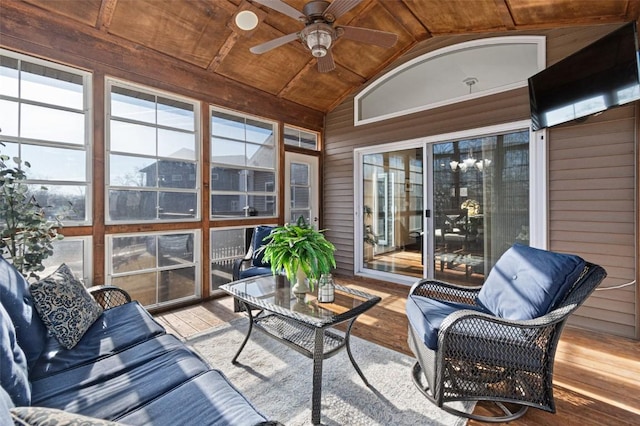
[{"left": 354, "top": 36, "right": 545, "bottom": 126}]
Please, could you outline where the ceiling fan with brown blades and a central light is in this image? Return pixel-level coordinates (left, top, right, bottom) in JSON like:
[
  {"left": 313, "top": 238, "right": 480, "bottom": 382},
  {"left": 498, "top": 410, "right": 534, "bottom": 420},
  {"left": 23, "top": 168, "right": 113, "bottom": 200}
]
[{"left": 249, "top": 0, "right": 398, "bottom": 72}]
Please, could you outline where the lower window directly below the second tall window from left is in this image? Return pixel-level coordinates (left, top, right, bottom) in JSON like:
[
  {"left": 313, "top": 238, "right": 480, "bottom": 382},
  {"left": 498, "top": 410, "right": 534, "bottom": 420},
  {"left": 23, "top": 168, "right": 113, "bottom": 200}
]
[{"left": 107, "top": 230, "right": 200, "bottom": 307}]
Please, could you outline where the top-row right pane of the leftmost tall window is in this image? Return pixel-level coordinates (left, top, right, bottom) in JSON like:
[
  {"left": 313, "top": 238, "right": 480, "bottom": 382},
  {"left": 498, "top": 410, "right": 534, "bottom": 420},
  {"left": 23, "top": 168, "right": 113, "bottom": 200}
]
[{"left": 20, "top": 61, "right": 84, "bottom": 110}]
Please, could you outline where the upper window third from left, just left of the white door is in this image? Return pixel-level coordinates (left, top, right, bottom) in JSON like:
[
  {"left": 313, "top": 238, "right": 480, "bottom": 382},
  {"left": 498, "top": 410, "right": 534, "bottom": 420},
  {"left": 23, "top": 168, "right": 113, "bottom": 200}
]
[{"left": 211, "top": 109, "right": 278, "bottom": 218}]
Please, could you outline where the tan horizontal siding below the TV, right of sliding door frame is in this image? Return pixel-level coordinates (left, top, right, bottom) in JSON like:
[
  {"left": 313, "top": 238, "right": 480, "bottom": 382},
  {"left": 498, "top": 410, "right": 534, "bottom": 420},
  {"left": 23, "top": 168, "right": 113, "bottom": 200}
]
[{"left": 548, "top": 105, "right": 637, "bottom": 337}]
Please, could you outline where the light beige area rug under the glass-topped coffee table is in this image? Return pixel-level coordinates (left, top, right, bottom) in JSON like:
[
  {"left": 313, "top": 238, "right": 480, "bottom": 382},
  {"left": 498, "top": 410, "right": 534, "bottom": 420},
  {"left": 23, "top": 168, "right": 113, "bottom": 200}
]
[{"left": 187, "top": 318, "right": 473, "bottom": 426}]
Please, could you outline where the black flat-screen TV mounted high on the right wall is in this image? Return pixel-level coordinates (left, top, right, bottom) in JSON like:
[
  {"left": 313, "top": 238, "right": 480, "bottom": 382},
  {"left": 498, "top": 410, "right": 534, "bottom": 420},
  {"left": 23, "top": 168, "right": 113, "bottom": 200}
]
[{"left": 529, "top": 22, "right": 640, "bottom": 130}]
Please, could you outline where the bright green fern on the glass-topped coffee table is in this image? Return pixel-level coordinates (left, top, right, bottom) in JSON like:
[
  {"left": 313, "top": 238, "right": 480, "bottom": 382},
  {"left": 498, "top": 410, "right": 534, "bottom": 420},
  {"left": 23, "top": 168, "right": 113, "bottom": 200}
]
[{"left": 261, "top": 216, "right": 336, "bottom": 293}]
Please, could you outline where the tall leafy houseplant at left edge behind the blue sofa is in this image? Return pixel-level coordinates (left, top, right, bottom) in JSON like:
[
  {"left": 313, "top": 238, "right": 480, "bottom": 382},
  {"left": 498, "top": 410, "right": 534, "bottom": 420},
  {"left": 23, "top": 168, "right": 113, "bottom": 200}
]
[{"left": 0, "top": 148, "right": 64, "bottom": 279}]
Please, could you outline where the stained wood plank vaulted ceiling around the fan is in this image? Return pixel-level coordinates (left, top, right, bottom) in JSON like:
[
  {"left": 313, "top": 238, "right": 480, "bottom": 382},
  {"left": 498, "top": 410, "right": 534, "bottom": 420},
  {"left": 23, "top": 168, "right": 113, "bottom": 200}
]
[{"left": 8, "top": 0, "right": 640, "bottom": 113}]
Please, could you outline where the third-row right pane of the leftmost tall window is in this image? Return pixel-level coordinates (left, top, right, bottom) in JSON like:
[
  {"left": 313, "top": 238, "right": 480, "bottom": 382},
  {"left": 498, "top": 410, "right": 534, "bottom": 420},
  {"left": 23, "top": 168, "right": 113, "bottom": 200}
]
[{"left": 22, "top": 144, "right": 87, "bottom": 182}]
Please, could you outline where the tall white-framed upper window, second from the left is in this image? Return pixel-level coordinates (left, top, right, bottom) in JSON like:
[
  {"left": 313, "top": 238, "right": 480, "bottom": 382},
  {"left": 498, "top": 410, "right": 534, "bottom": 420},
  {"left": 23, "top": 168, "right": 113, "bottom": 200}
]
[{"left": 106, "top": 81, "right": 200, "bottom": 222}]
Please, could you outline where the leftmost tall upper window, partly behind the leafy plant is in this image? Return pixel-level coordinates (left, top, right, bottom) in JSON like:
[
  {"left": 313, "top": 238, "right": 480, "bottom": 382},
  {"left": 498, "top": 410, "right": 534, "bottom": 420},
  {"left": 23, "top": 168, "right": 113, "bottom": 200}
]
[{"left": 0, "top": 50, "right": 92, "bottom": 225}]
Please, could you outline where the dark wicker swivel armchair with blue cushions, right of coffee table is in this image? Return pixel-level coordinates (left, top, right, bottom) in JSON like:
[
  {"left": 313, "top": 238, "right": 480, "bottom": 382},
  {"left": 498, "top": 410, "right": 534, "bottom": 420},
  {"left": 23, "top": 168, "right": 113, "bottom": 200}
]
[{"left": 406, "top": 244, "right": 607, "bottom": 422}]
